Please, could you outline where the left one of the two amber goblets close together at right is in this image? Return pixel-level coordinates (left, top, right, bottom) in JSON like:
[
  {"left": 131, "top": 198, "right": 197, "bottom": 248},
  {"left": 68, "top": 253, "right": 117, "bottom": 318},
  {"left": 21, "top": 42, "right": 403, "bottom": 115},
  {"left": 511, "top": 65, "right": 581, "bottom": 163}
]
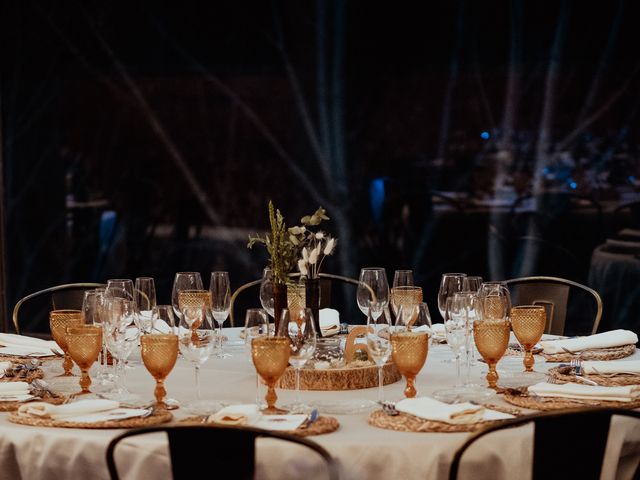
[{"left": 473, "top": 318, "right": 511, "bottom": 388}]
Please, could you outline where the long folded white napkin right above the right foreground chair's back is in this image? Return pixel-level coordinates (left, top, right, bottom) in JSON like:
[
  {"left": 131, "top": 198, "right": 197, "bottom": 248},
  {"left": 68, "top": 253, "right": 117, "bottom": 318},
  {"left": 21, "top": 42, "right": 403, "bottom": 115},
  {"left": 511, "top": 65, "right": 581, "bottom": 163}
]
[{"left": 528, "top": 382, "right": 640, "bottom": 402}]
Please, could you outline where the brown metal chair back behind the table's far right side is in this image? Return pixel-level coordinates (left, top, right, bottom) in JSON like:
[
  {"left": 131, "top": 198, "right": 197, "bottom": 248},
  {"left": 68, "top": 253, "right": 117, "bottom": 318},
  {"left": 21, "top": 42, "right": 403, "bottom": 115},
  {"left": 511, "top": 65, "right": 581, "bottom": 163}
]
[{"left": 505, "top": 276, "right": 602, "bottom": 335}]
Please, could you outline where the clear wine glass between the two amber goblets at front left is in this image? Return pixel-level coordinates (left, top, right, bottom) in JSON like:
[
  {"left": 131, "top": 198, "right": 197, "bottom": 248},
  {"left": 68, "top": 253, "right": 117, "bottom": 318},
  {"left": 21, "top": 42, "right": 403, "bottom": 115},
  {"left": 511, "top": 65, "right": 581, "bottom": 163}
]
[{"left": 178, "top": 302, "right": 216, "bottom": 415}]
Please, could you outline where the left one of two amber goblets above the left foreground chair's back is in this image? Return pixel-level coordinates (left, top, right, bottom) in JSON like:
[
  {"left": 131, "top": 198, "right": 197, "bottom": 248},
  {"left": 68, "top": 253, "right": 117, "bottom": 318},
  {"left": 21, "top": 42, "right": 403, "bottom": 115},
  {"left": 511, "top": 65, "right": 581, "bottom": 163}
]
[{"left": 140, "top": 333, "right": 178, "bottom": 410}]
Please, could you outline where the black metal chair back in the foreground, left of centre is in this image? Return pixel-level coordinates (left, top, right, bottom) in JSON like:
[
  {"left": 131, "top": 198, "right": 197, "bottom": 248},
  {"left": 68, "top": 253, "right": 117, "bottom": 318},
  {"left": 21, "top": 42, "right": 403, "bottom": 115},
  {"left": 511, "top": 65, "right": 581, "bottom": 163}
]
[{"left": 107, "top": 425, "right": 338, "bottom": 480}]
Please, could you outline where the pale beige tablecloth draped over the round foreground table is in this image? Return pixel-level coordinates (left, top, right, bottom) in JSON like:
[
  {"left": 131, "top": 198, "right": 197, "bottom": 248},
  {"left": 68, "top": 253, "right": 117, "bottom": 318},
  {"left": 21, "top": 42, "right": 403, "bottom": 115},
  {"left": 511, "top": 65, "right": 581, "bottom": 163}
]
[{"left": 0, "top": 329, "right": 640, "bottom": 480}]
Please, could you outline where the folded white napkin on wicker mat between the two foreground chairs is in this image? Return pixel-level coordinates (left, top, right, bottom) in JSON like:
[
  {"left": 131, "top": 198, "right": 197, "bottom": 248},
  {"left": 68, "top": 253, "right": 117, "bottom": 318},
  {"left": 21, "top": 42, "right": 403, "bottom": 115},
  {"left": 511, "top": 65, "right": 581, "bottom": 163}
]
[{"left": 396, "top": 397, "right": 513, "bottom": 424}]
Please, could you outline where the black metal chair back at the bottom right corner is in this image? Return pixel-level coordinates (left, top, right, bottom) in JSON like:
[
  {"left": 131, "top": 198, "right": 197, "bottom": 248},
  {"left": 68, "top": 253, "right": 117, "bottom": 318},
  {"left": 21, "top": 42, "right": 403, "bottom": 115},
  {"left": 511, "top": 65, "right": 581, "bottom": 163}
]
[{"left": 449, "top": 408, "right": 640, "bottom": 480}]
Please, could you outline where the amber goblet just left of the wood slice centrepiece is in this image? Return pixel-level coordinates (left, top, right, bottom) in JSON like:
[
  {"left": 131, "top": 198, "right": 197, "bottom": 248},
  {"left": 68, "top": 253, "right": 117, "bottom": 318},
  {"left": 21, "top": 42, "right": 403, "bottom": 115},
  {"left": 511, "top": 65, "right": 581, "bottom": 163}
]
[{"left": 251, "top": 337, "right": 291, "bottom": 413}]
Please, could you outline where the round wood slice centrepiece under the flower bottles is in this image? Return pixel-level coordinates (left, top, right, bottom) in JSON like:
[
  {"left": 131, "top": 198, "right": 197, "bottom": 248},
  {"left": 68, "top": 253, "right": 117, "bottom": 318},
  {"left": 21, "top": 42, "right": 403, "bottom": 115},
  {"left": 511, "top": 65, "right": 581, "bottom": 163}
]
[{"left": 278, "top": 362, "right": 402, "bottom": 390}]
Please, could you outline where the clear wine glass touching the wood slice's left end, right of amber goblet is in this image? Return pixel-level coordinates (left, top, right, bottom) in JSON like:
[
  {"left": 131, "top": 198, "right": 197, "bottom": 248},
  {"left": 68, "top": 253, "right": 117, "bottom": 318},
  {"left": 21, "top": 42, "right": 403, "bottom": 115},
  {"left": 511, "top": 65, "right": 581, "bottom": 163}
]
[{"left": 278, "top": 308, "right": 317, "bottom": 413}]
